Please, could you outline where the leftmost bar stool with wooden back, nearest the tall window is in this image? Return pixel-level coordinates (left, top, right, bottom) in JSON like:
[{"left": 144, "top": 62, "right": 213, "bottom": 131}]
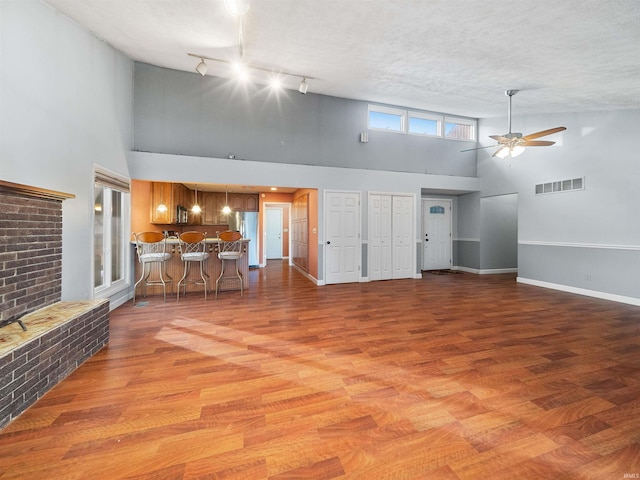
[{"left": 133, "top": 232, "right": 173, "bottom": 305}]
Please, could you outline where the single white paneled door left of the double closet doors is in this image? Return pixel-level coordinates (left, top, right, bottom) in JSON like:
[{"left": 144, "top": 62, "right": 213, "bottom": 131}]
[{"left": 324, "top": 191, "right": 360, "bottom": 284}]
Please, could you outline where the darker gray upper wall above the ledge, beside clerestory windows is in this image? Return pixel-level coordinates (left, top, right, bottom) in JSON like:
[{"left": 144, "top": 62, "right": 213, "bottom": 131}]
[{"left": 134, "top": 63, "right": 476, "bottom": 177}]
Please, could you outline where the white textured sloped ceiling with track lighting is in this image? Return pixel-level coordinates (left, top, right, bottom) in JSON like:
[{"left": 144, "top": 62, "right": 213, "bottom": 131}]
[{"left": 45, "top": 0, "right": 640, "bottom": 118}]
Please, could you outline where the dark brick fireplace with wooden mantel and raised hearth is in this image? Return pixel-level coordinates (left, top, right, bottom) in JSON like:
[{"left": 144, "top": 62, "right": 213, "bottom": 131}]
[{"left": 0, "top": 181, "right": 109, "bottom": 429}]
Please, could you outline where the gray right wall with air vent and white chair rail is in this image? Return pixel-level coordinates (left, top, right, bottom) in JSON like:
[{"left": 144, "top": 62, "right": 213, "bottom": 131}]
[{"left": 478, "top": 110, "right": 640, "bottom": 304}]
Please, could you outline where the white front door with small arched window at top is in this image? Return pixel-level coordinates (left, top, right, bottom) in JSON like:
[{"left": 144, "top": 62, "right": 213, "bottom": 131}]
[{"left": 422, "top": 200, "right": 452, "bottom": 270}]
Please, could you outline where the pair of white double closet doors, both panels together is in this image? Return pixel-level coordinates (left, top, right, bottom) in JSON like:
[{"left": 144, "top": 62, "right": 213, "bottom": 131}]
[{"left": 368, "top": 194, "right": 415, "bottom": 280}]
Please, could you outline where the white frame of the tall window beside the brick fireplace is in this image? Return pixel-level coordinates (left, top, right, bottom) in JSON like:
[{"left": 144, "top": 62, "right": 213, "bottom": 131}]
[{"left": 91, "top": 166, "right": 131, "bottom": 298}]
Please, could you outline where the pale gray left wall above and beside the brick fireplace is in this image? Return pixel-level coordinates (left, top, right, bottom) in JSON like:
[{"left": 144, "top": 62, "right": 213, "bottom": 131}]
[{"left": 0, "top": 0, "right": 133, "bottom": 300}]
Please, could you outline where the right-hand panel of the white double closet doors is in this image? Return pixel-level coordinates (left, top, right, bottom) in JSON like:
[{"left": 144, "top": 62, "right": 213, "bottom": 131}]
[{"left": 391, "top": 195, "right": 415, "bottom": 278}]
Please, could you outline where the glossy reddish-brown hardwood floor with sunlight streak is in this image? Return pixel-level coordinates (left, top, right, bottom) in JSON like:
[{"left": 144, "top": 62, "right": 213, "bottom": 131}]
[{"left": 0, "top": 262, "right": 640, "bottom": 480}]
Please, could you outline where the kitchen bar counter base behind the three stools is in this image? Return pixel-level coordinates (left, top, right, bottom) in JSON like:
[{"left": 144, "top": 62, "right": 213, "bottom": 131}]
[{"left": 131, "top": 237, "right": 249, "bottom": 298}]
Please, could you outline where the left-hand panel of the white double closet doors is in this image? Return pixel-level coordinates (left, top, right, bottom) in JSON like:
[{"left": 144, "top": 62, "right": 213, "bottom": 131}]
[{"left": 368, "top": 195, "right": 392, "bottom": 280}]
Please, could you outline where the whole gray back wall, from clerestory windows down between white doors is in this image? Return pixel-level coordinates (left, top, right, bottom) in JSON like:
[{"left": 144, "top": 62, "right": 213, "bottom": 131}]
[{"left": 131, "top": 63, "right": 479, "bottom": 280}]
